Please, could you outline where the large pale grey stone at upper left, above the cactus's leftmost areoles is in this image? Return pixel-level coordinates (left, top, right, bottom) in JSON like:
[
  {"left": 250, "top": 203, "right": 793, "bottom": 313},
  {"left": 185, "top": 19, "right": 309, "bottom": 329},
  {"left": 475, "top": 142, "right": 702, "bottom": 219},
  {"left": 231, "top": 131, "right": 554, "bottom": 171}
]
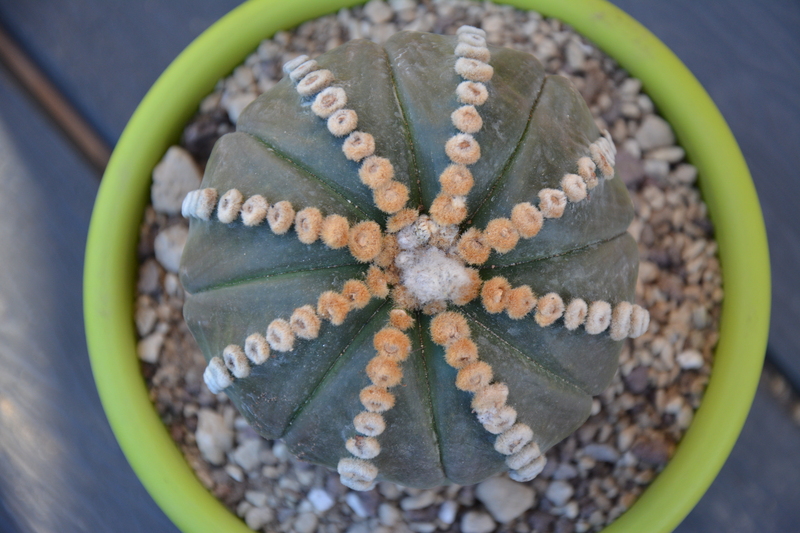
[{"left": 150, "top": 146, "right": 203, "bottom": 215}]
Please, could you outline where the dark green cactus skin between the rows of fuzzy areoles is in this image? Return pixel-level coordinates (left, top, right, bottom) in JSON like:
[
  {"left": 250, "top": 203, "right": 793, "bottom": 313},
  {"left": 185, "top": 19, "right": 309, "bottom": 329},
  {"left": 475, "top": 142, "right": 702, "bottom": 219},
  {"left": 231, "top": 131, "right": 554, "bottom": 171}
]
[{"left": 181, "top": 32, "right": 638, "bottom": 487}]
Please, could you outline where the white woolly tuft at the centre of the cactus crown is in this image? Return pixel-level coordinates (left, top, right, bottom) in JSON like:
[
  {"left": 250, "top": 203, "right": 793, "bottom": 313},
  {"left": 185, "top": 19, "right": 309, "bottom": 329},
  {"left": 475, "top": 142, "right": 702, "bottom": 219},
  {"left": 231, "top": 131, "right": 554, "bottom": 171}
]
[{"left": 395, "top": 246, "right": 470, "bottom": 304}]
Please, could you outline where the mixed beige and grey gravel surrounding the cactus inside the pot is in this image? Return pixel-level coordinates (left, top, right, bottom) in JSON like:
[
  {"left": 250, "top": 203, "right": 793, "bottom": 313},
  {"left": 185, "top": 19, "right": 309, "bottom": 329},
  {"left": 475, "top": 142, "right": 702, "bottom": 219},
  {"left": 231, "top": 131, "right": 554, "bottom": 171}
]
[{"left": 135, "top": 0, "right": 722, "bottom": 533}]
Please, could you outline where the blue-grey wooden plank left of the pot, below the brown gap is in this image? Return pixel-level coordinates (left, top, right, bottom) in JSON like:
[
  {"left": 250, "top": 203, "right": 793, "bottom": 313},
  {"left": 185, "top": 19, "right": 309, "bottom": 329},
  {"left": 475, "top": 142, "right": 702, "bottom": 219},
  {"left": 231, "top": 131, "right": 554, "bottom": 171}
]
[{"left": 0, "top": 65, "right": 176, "bottom": 533}]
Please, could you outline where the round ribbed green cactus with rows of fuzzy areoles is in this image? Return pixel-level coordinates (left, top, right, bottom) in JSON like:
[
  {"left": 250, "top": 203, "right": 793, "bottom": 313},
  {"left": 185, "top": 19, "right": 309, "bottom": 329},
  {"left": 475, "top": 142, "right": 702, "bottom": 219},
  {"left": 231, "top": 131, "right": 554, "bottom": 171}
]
[{"left": 181, "top": 27, "right": 649, "bottom": 490}]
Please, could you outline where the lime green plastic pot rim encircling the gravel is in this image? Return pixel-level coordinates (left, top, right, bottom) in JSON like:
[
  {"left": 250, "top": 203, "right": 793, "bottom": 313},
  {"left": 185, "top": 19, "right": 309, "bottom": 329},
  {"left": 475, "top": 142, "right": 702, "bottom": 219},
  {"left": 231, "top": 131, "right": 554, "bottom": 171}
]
[{"left": 84, "top": 0, "right": 770, "bottom": 533}]
